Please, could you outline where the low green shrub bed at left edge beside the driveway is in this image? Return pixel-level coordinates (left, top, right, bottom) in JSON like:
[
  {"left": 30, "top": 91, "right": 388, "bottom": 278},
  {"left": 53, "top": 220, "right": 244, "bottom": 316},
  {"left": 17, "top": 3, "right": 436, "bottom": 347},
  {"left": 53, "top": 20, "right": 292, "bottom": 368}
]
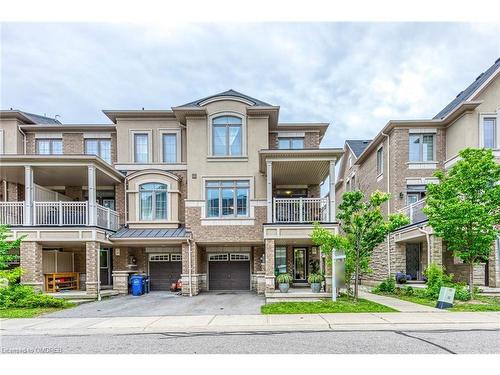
[{"left": 0, "top": 285, "right": 68, "bottom": 309}]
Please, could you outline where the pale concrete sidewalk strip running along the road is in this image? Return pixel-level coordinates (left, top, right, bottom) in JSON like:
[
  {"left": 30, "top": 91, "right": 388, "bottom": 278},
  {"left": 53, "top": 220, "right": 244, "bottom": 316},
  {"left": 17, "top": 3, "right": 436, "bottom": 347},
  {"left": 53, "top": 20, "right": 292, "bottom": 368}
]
[{"left": 0, "top": 312, "right": 500, "bottom": 336}]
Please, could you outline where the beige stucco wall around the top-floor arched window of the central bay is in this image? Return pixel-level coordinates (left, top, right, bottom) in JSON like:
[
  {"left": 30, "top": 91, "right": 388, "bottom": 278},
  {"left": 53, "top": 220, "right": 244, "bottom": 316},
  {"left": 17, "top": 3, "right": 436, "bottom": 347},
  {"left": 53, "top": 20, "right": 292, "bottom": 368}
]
[{"left": 186, "top": 101, "right": 269, "bottom": 200}]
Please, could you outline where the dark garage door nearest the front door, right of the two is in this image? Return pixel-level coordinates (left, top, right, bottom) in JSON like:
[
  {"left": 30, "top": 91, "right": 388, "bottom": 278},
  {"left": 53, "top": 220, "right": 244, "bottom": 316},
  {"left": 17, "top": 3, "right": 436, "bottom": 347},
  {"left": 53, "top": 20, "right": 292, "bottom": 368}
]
[{"left": 208, "top": 254, "right": 250, "bottom": 290}]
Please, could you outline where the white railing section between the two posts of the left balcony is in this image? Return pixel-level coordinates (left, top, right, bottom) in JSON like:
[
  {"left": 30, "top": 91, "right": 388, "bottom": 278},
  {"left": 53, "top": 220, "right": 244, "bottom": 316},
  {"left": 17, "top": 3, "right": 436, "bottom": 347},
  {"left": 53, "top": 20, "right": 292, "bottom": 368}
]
[{"left": 33, "top": 201, "right": 88, "bottom": 226}]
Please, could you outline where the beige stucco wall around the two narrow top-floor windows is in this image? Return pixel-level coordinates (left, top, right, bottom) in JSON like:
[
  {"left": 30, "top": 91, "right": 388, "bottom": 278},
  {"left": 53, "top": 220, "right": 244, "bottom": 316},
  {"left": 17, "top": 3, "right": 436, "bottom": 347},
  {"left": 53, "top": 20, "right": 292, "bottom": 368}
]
[{"left": 116, "top": 118, "right": 186, "bottom": 164}]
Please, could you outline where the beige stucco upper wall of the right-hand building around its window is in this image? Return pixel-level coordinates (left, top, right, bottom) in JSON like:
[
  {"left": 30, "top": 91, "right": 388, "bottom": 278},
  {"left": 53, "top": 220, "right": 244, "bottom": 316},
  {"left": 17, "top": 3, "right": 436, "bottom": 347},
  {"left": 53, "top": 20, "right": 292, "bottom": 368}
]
[{"left": 446, "top": 76, "right": 500, "bottom": 160}]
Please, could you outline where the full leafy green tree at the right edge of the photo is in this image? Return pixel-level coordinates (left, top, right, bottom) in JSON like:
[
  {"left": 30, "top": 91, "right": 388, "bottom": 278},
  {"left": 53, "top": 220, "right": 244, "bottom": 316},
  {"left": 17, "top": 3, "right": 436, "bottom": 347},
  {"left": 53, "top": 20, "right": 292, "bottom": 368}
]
[{"left": 424, "top": 148, "right": 500, "bottom": 298}]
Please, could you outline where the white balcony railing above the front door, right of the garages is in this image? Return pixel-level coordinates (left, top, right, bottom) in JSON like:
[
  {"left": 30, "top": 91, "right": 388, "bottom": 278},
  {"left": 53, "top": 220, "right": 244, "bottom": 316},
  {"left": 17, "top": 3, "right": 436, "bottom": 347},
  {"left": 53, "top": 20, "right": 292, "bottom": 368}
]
[{"left": 273, "top": 198, "right": 329, "bottom": 223}]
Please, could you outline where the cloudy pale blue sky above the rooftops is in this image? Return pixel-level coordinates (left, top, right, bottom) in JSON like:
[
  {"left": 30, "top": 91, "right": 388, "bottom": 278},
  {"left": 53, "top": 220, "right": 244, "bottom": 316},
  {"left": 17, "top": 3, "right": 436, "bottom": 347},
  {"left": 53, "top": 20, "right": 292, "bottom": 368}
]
[{"left": 0, "top": 22, "right": 500, "bottom": 147}]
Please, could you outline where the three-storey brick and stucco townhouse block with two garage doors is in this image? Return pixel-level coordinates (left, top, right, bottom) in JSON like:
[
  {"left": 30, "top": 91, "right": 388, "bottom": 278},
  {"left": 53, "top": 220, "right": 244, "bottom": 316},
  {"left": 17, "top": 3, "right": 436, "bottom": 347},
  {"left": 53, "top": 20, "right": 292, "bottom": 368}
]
[{"left": 0, "top": 90, "right": 343, "bottom": 295}]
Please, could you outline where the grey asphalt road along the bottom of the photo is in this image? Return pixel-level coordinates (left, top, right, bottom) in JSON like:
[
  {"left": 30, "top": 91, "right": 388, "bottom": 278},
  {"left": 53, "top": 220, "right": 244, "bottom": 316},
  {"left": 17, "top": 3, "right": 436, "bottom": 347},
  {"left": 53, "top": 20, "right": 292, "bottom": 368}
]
[{"left": 0, "top": 330, "right": 500, "bottom": 354}]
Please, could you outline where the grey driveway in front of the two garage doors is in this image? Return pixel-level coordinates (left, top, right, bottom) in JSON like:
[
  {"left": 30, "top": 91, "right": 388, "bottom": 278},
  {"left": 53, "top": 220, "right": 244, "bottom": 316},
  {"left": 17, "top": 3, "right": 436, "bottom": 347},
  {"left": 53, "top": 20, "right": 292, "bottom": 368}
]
[{"left": 44, "top": 292, "right": 264, "bottom": 318}]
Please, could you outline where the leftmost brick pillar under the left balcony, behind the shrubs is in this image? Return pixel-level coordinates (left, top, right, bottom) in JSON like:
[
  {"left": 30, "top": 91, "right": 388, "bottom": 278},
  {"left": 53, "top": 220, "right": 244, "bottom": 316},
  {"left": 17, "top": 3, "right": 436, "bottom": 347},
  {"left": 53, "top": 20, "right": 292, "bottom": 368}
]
[{"left": 19, "top": 241, "right": 44, "bottom": 291}]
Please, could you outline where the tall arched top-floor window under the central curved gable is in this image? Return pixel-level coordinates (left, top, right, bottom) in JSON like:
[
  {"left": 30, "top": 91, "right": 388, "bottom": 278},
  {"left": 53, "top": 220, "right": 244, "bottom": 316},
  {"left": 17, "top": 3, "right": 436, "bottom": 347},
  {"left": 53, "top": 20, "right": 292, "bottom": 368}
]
[{"left": 212, "top": 116, "right": 242, "bottom": 156}]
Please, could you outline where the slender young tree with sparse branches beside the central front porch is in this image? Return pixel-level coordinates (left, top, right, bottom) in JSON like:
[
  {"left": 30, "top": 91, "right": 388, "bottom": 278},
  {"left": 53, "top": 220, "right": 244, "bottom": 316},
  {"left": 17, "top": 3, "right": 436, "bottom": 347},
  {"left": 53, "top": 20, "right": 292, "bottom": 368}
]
[{"left": 312, "top": 191, "right": 409, "bottom": 301}]
